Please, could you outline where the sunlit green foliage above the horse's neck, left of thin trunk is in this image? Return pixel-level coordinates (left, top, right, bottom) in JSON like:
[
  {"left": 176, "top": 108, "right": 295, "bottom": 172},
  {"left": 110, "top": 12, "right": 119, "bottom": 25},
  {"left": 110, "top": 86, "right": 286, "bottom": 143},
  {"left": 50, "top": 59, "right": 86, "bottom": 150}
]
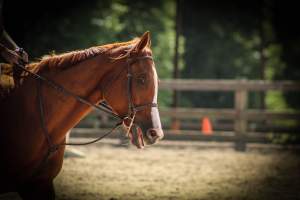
[{"left": 25, "top": 0, "right": 175, "bottom": 105}]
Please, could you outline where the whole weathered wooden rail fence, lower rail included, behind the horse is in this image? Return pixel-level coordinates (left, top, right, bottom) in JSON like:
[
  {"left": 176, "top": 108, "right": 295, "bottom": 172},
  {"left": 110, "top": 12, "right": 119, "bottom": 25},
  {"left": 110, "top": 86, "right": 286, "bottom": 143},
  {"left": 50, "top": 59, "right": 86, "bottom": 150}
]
[{"left": 75, "top": 79, "right": 300, "bottom": 150}]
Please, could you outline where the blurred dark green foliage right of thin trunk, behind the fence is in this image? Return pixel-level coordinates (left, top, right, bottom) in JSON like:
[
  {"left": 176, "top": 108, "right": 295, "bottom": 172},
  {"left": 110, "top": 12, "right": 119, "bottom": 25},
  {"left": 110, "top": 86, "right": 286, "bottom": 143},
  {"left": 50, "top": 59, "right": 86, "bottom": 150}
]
[{"left": 180, "top": 0, "right": 300, "bottom": 109}]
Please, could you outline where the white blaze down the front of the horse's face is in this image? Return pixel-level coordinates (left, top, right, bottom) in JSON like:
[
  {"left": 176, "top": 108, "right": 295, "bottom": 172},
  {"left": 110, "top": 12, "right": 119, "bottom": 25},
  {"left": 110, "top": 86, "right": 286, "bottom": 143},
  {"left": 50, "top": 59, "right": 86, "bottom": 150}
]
[{"left": 151, "top": 65, "right": 161, "bottom": 129}]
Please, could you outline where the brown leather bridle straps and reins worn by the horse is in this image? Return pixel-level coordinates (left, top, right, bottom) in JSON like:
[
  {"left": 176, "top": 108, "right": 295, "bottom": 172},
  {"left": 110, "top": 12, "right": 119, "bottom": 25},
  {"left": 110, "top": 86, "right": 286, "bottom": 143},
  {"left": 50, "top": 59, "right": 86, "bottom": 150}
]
[{"left": 16, "top": 56, "right": 157, "bottom": 156}]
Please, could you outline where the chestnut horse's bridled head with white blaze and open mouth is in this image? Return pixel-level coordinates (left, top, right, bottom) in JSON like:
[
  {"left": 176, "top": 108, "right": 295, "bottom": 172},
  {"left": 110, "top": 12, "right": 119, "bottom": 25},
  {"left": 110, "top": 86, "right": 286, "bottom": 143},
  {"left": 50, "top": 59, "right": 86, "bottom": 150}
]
[{"left": 103, "top": 32, "right": 164, "bottom": 148}]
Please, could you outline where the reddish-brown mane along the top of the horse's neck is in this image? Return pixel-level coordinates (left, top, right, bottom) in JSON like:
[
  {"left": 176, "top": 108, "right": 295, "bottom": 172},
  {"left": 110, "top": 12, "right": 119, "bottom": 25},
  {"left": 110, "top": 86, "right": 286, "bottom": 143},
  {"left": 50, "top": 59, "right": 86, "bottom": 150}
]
[{"left": 27, "top": 38, "right": 139, "bottom": 72}]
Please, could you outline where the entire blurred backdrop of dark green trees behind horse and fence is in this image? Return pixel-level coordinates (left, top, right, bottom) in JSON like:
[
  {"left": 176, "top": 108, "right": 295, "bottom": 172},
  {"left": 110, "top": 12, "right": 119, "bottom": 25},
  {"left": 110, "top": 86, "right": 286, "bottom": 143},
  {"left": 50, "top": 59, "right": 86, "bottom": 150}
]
[{"left": 4, "top": 0, "right": 300, "bottom": 109}]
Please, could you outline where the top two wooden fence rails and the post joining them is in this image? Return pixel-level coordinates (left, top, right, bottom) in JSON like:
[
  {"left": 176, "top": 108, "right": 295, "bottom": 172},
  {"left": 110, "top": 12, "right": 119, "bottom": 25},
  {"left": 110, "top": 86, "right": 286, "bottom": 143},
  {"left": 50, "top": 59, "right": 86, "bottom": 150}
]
[{"left": 160, "top": 79, "right": 300, "bottom": 150}]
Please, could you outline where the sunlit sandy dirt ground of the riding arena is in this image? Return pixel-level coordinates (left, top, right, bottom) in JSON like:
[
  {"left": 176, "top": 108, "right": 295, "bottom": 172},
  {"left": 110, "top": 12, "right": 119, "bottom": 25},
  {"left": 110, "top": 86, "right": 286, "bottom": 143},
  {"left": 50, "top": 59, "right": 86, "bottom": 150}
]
[{"left": 0, "top": 139, "right": 300, "bottom": 200}]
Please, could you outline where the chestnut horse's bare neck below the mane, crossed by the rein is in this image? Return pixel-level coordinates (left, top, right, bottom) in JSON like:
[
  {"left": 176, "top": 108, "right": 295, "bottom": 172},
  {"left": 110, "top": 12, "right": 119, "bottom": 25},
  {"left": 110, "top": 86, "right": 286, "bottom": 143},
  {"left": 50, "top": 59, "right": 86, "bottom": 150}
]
[{"left": 21, "top": 53, "right": 117, "bottom": 143}]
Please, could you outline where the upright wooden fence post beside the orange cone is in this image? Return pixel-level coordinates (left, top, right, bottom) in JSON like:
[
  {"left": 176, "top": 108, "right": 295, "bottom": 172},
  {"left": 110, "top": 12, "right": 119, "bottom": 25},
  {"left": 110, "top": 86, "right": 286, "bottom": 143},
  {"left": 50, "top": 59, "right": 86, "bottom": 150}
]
[{"left": 234, "top": 80, "right": 248, "bottom": 151}]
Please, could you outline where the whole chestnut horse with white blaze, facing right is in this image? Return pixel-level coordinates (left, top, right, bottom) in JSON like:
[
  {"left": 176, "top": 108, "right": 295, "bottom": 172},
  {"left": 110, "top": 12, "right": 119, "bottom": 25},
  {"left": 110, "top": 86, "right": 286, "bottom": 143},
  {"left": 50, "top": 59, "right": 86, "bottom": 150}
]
[{"left": 0, "top": 32, "right": 163, "bottom": 199}]
